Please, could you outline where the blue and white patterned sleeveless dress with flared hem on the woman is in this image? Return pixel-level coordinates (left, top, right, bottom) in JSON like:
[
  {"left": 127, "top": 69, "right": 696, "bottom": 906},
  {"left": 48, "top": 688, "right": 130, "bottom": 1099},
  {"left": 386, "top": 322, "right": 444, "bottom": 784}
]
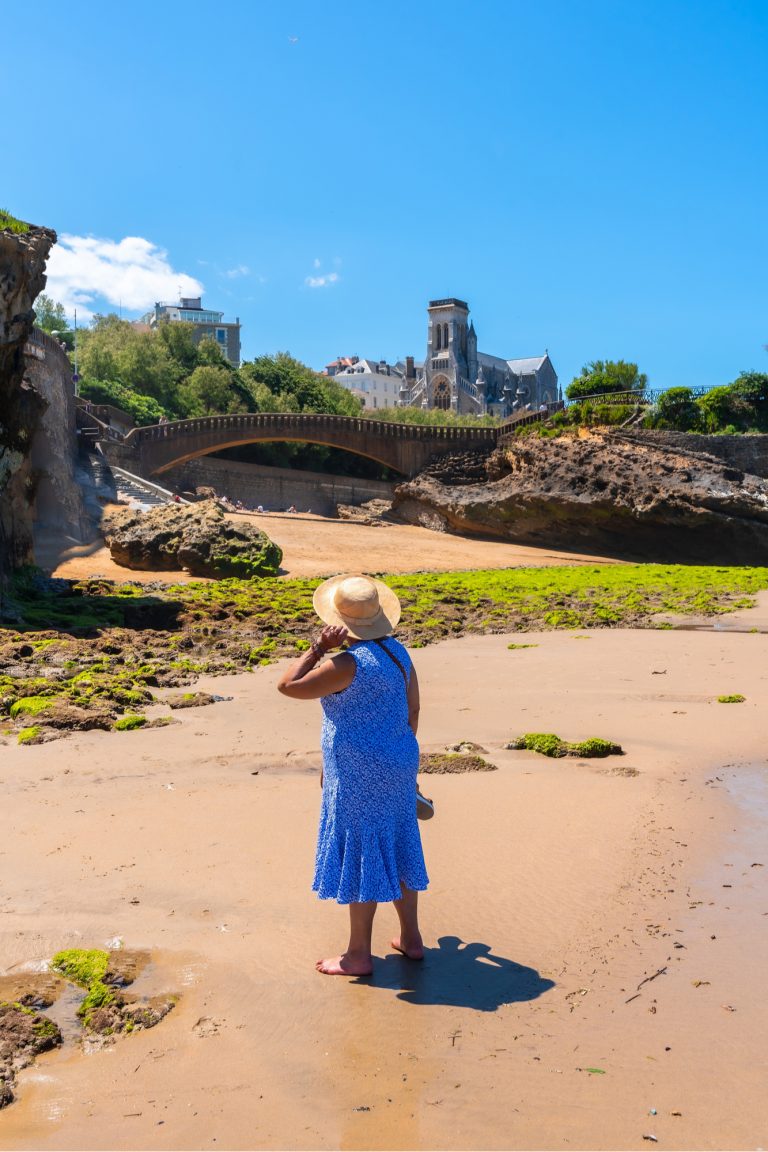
[{"left": 312, "top": 636, "right": 429, "bottom": 904}]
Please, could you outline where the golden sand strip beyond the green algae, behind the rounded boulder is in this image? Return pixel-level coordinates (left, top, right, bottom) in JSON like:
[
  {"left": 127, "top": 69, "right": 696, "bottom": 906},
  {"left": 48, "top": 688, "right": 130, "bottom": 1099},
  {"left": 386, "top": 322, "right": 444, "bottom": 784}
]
[{"left": 38, "top": 513, "right": 618, "bottom": 583}]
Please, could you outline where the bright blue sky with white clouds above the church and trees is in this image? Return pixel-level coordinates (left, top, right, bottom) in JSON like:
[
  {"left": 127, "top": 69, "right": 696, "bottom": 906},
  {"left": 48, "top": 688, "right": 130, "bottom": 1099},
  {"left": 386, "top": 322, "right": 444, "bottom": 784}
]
[{"left": 0, "top": 0, "right": 768, "bottom": 387}]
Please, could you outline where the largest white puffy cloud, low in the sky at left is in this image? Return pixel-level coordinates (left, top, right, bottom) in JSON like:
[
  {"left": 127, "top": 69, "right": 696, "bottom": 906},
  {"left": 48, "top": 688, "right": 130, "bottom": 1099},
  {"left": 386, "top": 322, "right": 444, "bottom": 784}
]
[{"left": 45, "top": 235, "right": 203, "bottom": 319}]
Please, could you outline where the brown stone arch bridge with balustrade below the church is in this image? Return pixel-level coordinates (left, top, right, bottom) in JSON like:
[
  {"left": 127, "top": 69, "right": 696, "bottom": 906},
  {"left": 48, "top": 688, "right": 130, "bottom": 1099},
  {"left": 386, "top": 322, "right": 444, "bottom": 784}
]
[{"left": 105, "top": 412, "right": 515, "bottom": 477}]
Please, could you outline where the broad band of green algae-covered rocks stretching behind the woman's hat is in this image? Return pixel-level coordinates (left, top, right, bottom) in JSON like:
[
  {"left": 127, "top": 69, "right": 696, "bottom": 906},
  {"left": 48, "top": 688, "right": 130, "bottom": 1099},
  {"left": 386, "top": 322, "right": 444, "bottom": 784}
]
[{"left": 0, "top": 563, "right": 768, "bottom": 737}]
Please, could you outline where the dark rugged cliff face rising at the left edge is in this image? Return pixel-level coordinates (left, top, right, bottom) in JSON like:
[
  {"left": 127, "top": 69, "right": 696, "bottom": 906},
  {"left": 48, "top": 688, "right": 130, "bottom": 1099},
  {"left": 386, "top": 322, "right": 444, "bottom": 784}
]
[{"left": 0, "top": 228, "right": 56, "bottom": 578}]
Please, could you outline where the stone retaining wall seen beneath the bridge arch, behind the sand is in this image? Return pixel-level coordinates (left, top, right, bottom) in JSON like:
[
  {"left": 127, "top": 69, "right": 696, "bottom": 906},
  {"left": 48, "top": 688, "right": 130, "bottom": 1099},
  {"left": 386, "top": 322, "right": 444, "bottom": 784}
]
[{"left": 161, "top": 456, "right": 395, "bottom": 516}]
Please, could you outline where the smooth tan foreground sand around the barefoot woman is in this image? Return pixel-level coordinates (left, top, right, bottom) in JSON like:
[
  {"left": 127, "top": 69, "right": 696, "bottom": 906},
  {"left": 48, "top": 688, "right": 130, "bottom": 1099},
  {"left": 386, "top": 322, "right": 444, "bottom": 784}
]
[{"left": 0, "top": 550, "right": 768, "bottom": 1149}]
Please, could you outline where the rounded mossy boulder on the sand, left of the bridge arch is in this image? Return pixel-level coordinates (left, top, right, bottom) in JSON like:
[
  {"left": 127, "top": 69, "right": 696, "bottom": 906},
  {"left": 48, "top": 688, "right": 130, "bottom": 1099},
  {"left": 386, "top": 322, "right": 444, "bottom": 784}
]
[{"left": 104, "top": 501, "right": 282, "bottom": 579}]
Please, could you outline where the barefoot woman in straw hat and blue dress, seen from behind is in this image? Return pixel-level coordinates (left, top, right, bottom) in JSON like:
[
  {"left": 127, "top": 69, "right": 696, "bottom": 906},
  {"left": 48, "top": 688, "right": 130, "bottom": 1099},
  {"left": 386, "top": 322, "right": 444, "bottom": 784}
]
[{"left": 277, "top": 576, "right": 428, "bottom": 976}]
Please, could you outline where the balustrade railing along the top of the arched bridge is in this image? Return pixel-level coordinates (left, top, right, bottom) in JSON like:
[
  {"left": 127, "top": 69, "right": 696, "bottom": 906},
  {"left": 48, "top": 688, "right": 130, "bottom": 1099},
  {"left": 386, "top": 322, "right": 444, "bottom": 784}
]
[{"left": 126, "top": 412, "right": 496, "bottom": 447}]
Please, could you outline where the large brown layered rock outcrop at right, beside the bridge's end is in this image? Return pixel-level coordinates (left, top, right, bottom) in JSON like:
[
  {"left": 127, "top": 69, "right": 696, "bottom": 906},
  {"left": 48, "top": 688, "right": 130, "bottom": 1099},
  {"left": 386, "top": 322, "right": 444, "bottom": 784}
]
[{"left": 393, "top": 431, "right": 768, "bottom": 564}]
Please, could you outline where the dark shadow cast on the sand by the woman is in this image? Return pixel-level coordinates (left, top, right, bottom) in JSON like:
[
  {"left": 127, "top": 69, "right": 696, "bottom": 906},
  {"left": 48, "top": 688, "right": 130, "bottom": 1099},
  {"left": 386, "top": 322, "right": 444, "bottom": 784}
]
[{"left": 359, "top": 937, "right": 555, "bottom": 1011}]
